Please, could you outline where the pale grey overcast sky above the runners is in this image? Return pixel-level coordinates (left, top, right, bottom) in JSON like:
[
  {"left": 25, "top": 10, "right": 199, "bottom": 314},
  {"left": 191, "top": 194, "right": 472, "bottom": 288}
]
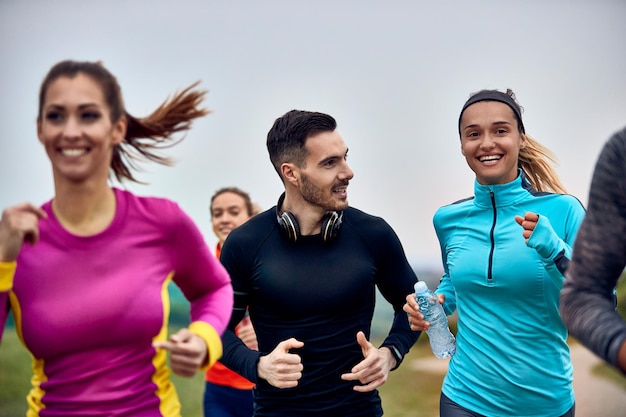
[{"left": 0, "top": 0, "right": 626, "bottom": 266}]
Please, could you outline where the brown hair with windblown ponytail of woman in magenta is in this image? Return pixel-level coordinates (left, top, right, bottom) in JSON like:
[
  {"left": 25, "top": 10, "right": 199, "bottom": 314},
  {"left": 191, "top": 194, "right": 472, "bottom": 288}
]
[{"left": 37, "top": 60, "right": 209, "bottom": 183}]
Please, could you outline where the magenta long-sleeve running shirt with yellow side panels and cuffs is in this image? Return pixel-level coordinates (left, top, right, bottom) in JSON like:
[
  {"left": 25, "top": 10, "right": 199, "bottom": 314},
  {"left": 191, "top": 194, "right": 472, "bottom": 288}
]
[{"left": 0, "top": 189, "right": 233, "bottom": 417}]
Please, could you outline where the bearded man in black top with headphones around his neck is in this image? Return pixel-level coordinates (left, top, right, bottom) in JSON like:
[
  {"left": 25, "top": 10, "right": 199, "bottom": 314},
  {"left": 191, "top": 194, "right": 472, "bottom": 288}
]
[{"left": 220, "top": 110, "right": 420, "bottom": 417}]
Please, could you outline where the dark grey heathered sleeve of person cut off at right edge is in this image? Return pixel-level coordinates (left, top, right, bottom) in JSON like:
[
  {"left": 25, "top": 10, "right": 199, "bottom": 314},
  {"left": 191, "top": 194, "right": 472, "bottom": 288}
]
[{"left": 560, "top": 129, "right": 626, "bottom": 372}]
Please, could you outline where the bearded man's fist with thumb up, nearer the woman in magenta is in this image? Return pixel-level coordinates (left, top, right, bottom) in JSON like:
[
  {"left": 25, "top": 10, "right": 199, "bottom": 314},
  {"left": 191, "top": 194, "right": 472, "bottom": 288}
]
[{"left": 257, "top": 337, "right": 304, "bottom": 388}]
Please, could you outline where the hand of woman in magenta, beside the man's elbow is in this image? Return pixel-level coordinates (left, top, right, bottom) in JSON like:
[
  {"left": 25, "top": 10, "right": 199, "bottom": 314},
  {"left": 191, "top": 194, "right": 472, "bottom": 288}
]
[{"left": 152, "top": 329, "right": 208, "bottom": 377}]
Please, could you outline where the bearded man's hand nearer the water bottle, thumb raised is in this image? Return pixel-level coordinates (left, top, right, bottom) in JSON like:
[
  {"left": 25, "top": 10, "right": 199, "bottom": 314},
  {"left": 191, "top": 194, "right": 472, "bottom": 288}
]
[{"left": 341, "top": 332, "right": 396, "bottom": 392}]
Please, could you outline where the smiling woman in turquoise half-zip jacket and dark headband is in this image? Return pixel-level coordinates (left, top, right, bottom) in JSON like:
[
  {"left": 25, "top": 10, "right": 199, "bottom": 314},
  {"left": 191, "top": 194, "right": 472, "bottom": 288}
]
[{"left": 404, "top": 90, "right": 585, "bottom": 417}]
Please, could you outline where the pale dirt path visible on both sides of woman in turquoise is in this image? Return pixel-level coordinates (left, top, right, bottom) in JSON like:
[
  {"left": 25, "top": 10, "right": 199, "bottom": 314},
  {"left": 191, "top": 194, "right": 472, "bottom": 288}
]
[{"left": 411, "top": 344, "right": 626, "bottom": 417}]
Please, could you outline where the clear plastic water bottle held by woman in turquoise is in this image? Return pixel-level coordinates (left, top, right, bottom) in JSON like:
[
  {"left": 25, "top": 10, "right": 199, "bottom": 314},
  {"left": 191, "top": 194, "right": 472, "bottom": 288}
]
[{"left": 415, "top": 281, "right": 456, "bottom": 358}]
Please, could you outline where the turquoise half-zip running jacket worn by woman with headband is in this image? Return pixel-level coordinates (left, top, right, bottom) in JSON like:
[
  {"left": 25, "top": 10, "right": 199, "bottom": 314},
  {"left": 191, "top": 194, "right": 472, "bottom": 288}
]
[{"left": 433, "top": 171, "right": 585, "bottom": 417}]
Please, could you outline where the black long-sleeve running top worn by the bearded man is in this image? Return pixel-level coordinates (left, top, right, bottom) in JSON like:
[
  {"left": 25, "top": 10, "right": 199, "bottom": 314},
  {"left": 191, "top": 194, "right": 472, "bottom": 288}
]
[{"left": 220, "top": 208, "right": 419, "bottom": 417}]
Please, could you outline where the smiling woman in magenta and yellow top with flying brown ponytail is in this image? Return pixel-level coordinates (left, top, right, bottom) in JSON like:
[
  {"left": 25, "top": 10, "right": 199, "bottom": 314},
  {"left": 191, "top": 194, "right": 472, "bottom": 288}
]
[{"left": 0, "top": 61, "right": 233, "bottom": 417}]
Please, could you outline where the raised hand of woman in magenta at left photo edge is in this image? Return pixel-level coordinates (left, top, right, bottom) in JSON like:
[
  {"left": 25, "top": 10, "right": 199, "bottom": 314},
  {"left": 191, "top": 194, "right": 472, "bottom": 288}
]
[{"left": 0, "top": 203, "right": 47, "bottom": 262}]
